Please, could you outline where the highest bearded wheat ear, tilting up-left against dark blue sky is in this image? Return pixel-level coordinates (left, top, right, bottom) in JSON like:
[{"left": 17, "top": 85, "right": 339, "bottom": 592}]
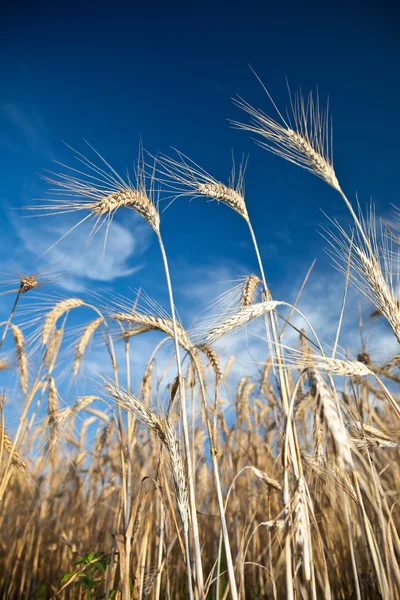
[{"left": 232, "top": 88, "right": 340, "bottom": 191}]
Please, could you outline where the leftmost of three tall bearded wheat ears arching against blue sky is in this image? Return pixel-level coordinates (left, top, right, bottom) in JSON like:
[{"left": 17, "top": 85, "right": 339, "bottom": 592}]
[{"left": 29, "top": 146, "right": 160, "bottom": 248}]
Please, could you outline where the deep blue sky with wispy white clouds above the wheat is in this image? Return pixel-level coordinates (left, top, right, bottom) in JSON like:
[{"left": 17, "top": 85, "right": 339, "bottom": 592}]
[{"left": 0, "top": 1, "right": 400, "bottom": 422}]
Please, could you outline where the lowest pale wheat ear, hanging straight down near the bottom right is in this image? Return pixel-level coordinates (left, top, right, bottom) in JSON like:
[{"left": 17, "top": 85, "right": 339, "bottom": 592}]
[{"left": 292, "top": 476, "right": 311, "bottom": 581}]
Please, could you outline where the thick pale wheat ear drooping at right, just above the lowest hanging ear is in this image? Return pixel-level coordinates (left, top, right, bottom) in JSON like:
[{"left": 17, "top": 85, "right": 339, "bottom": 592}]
[{"left": 308, "top": 367, "right": 354, "bottom": 471}]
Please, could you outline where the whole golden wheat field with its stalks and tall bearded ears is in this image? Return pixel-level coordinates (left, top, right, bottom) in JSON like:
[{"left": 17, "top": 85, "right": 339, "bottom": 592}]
[{"left": 0, "top": 85, "right": 400, "bottom": 600}]
